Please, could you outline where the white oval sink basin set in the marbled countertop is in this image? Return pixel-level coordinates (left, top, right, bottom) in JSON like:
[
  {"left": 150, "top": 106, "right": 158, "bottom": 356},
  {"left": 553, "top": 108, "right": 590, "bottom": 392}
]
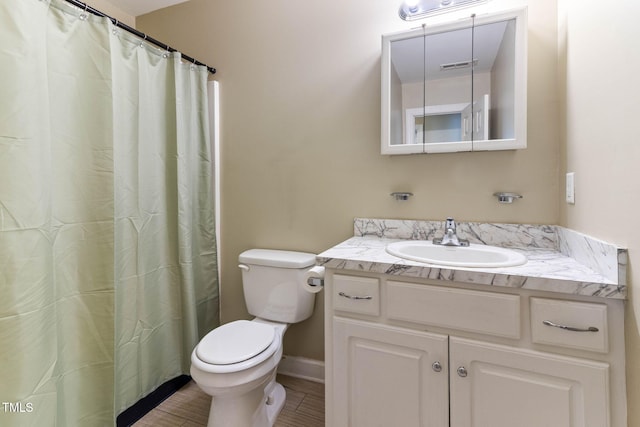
[{"left": 386, "top": 240, "right": 527, "bottom": 268}]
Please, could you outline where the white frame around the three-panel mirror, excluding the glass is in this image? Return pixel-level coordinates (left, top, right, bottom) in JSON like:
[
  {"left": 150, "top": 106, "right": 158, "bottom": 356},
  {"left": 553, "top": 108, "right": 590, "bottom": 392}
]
[{"left": 380, "top": 7, "right": 528, "bottom": 155}]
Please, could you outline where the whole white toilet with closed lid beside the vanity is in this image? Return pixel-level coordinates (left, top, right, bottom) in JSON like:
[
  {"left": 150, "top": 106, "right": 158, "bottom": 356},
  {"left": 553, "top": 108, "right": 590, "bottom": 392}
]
[{"left": 191, "top": 249, "right": 316, "bottom": 427}]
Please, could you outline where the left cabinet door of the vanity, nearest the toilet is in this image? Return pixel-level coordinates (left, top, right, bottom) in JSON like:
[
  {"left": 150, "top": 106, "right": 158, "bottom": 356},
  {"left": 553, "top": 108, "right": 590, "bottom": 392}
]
[{"left": 327, "top": 317, "right": 449, "bottom": 427}]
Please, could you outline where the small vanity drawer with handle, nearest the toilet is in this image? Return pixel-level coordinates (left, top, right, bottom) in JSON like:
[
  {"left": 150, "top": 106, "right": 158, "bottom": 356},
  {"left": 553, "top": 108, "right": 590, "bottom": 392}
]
[{"left": 333, "top": 274, "right": 380, "bottom": 316}]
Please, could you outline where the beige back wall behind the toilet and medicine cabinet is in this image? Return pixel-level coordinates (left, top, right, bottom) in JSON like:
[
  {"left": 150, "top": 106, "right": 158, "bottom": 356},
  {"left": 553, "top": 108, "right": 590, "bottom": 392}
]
[{"left": 137, "top": 0, "right": 559, "bottom": 359}]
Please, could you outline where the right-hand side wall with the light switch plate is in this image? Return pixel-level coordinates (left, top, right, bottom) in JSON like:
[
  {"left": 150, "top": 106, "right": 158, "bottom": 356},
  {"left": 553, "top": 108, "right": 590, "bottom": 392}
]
[{"left": 559, "top": 0, "right": 640, "bottom": 426}]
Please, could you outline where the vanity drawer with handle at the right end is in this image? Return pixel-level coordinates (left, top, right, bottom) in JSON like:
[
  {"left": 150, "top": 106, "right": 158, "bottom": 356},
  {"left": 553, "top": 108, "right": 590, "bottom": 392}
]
[{"left": 531, "top": 298, "right": 609, "bottom": 353}]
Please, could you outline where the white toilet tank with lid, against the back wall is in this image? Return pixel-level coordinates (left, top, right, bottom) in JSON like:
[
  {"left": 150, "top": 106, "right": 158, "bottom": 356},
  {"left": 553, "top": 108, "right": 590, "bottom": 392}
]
[{"left": 238, "top": 249, "right": 316, "bottom": 323}]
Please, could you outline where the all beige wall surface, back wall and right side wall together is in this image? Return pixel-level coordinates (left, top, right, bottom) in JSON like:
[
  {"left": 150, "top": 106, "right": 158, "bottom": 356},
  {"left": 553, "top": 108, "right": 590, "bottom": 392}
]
[{"left": 138, "top": 0, "right": 640, "bottom": 426}]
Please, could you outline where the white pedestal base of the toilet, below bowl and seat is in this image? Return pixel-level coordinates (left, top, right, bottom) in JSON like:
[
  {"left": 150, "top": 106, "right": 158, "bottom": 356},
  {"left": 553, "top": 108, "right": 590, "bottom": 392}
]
[{"left": 207, "top": 371, "right": 286, "bottom": 427}]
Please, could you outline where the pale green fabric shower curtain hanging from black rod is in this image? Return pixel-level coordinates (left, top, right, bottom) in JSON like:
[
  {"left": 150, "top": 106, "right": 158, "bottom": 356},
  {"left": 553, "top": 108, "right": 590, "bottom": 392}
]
[{"left": 0, "top": 0, "right": 218, "bottom": 427}]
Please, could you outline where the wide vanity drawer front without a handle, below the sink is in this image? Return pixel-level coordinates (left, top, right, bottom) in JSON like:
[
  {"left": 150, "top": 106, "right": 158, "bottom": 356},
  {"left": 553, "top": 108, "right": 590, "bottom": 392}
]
[{"left": 387, "top": 281, "right": 520, "bottom": 339}]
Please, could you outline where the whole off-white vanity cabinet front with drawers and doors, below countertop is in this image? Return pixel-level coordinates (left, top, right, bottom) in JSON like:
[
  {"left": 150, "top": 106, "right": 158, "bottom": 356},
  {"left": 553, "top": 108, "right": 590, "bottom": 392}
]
[{"left": 325, "top": 269, "right": 626, "bottom": 427}]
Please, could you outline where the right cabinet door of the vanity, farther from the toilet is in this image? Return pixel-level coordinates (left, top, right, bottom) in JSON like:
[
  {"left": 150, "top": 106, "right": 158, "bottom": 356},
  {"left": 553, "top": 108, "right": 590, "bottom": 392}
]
[{"left": 450, "top": 337, "right": 610, "bottom": 427}]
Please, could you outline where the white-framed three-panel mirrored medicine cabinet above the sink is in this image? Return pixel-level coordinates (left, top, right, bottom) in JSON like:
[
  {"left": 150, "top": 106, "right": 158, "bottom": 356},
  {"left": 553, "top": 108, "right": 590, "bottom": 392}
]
[{"left": 381, "top": 9, "right": 527, "bottom": 154}]
